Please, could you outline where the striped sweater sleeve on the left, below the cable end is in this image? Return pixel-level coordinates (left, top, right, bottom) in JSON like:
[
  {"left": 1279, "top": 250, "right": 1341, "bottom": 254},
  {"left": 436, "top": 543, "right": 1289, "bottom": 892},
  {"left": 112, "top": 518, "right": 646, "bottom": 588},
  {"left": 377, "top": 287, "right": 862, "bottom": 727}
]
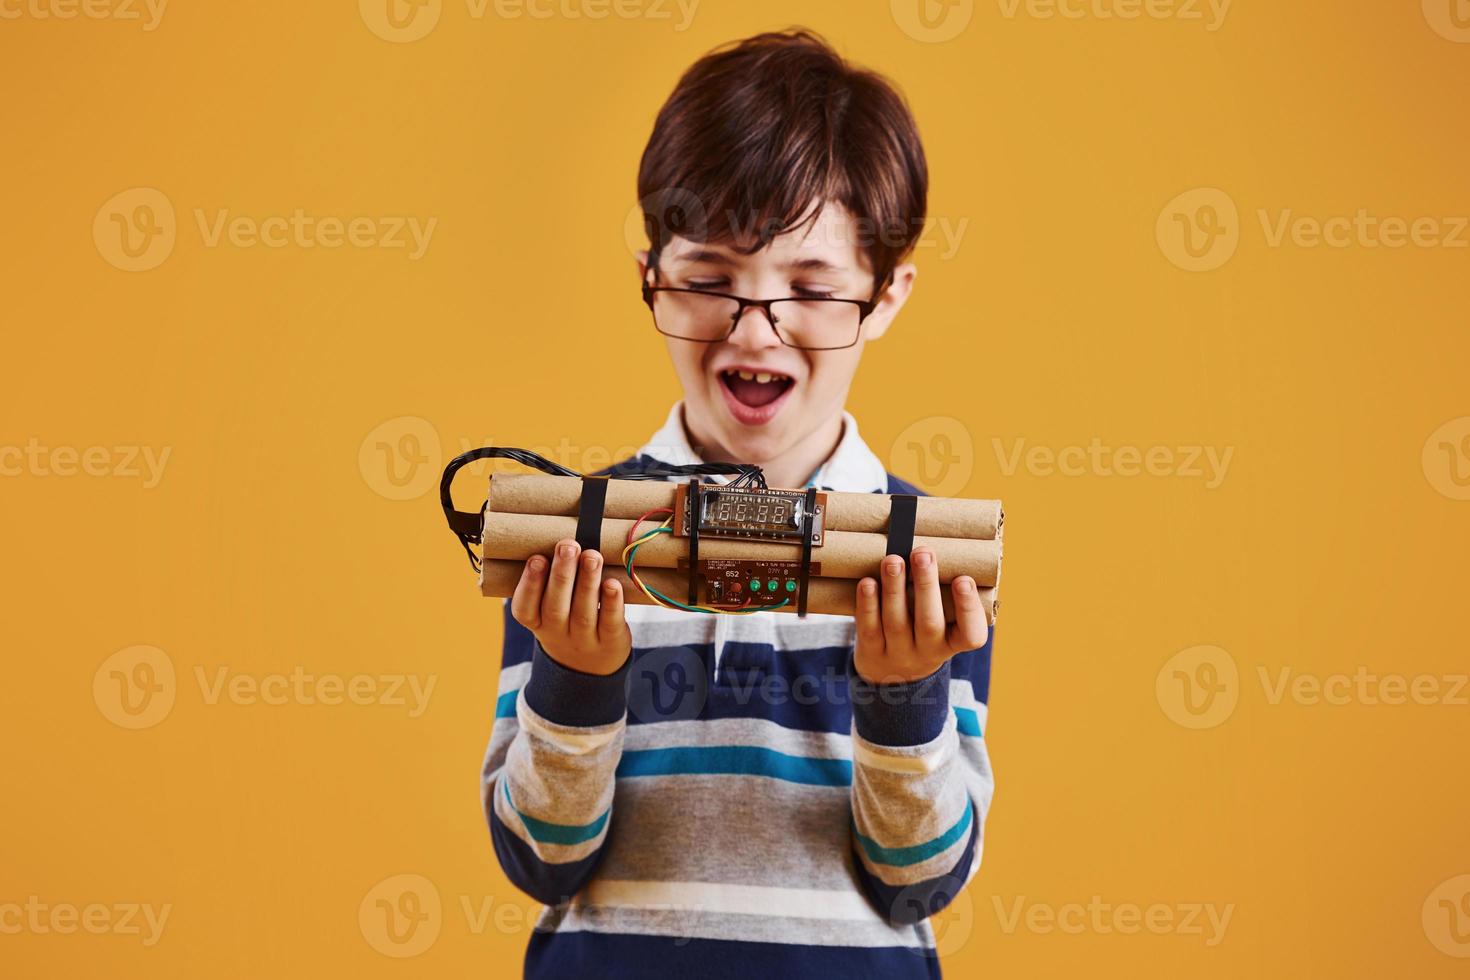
[{"left": 481, "top": 602, "right": 628, "bottom": 905}]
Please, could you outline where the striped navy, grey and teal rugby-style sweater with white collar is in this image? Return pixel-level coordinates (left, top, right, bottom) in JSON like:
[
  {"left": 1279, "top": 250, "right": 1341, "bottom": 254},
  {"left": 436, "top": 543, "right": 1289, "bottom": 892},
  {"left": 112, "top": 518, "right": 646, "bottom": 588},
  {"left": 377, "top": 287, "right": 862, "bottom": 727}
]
[{"left": 482, "top": 404, "right": 994, "bottom": 980}]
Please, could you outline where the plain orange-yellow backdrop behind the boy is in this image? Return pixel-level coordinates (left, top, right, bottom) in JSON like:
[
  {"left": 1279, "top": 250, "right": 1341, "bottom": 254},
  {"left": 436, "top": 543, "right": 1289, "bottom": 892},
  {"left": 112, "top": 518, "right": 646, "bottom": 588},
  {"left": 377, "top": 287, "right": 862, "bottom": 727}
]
[{"left": 0, "top": 0, "right": 1470, "bottom": 977}]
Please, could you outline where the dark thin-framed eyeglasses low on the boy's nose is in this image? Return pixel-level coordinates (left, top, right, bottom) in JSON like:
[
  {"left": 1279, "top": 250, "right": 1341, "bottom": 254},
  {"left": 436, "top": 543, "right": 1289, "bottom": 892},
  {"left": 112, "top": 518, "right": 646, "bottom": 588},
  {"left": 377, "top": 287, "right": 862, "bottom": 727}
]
[{"left": 644, "top": 282, "right": 878, "bottom": 351}]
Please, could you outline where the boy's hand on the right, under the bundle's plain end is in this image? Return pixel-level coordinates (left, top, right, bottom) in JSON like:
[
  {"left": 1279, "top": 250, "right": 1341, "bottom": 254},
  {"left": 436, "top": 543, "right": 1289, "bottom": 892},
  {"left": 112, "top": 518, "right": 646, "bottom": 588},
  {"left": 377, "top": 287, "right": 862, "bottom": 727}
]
[{"left": 853, "top": 548, "right": 989, "bottom": 685}]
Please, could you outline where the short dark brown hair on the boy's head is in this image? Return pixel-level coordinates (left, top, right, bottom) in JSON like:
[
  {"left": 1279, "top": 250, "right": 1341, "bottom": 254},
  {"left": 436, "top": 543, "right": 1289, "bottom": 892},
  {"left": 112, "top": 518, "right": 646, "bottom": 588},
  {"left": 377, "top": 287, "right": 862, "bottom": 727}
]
[{"left": 638, "top": 29, "right": 929, "bottom": 287}]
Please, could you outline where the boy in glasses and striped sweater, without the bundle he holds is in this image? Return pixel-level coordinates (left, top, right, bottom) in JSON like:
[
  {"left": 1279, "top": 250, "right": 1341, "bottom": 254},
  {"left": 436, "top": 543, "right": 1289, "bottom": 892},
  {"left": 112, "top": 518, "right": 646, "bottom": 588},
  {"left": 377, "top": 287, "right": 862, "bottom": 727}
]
[{"left": 482, "top": 32, "right": 994, "bottom": 979}]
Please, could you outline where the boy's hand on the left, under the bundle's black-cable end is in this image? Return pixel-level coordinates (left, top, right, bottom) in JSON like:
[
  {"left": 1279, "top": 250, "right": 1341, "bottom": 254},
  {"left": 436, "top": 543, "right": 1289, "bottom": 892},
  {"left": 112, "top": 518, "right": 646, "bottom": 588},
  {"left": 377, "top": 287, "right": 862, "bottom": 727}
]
[{"left": 510, "top": 538, "right": 634, "bottom": 674}]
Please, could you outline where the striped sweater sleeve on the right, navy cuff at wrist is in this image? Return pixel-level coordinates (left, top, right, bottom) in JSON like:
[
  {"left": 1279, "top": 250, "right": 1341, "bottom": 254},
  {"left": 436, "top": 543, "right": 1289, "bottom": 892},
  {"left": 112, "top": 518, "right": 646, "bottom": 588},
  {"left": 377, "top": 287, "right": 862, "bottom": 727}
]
[{"left": 850, "top": 630, "right": 995, "bottom": 924}]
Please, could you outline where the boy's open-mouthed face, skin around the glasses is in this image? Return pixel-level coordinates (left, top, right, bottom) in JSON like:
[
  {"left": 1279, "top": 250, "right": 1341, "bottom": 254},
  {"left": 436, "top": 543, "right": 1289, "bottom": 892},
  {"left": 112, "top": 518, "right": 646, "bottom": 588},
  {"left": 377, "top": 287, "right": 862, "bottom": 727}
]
[{"left": 639, "top": 204, "right": 914, "bottom": 463}]
